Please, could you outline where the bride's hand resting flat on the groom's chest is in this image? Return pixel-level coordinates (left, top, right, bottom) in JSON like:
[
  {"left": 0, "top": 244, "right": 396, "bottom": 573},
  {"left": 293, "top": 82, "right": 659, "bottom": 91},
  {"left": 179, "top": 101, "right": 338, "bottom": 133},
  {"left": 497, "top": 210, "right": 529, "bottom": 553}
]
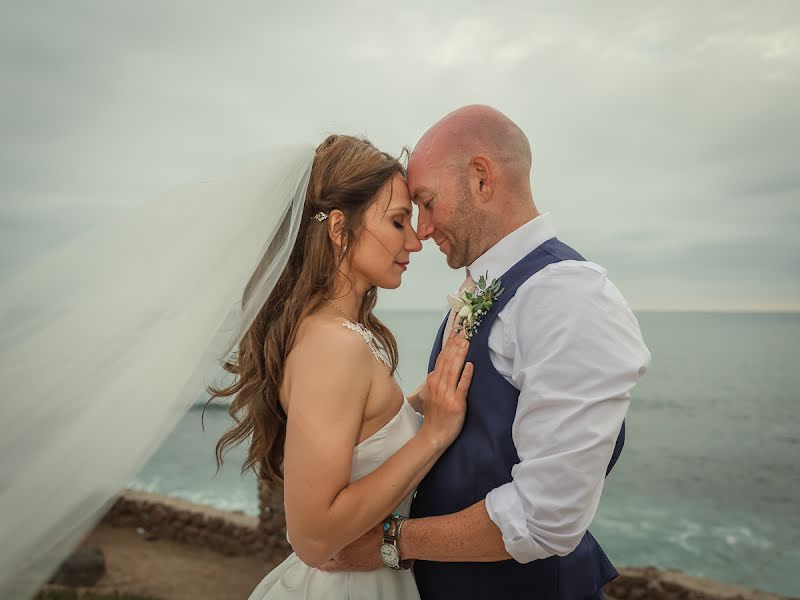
[{"left": 420, "top": 333, "right": 474, "bottom": 448}]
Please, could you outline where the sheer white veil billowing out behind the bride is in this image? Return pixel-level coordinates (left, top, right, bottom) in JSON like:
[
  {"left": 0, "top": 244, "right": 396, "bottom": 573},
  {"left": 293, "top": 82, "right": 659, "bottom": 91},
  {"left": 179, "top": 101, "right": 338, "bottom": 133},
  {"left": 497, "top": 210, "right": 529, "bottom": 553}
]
[{"left": 0, "top": 145, "right": 314, "bottom": 598}]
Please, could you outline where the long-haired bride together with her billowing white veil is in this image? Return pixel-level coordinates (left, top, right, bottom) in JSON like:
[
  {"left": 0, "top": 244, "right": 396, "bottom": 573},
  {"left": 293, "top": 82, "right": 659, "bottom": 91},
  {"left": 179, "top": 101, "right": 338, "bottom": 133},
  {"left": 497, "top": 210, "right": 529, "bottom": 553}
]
[{"left": 0, "top": 129, "right": 472, "bottom": 599}]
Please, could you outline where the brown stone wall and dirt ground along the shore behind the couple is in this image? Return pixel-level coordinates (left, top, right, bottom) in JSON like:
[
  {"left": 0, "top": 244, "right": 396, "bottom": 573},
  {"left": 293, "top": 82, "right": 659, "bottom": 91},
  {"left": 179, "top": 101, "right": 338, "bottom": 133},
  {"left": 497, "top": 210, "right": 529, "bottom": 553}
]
[{"left": 40, "top": 491, "right": 796, "bottom": 600}]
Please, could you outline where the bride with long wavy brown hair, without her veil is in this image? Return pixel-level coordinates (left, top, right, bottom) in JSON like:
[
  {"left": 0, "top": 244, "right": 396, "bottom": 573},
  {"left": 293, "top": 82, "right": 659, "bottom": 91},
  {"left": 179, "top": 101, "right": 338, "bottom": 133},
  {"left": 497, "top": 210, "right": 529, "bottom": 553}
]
[{"left": 209, "top": 135, "right": 472, "bottom": 600}]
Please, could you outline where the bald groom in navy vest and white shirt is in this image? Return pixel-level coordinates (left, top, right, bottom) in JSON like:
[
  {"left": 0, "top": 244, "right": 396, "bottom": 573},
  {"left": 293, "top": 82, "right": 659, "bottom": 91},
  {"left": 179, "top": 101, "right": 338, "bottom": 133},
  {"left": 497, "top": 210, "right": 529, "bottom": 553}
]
[{"left": 324, "top": 106, "right": 650, "bottom": 600}]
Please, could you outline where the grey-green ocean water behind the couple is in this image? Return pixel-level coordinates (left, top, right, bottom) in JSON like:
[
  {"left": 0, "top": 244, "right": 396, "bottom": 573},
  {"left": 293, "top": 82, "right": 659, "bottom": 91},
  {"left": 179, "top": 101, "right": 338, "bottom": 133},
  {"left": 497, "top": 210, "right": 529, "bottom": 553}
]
[{"left": 130, "top": 311, "right": 800, "bottom": 596}]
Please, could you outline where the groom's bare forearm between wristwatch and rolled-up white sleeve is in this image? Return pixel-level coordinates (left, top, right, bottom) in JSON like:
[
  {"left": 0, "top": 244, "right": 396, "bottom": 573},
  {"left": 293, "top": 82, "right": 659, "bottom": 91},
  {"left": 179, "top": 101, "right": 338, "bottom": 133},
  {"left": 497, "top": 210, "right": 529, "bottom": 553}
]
[{"left": 400, "top": 500, "right": 511, "bottom": 562}]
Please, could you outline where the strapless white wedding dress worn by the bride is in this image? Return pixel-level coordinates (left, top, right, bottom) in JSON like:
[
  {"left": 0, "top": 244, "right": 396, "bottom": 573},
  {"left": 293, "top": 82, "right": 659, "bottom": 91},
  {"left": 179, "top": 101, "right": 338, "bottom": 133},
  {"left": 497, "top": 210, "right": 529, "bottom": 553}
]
[{"left": 249, "top": 325, "right": 422, "bottom": 600}]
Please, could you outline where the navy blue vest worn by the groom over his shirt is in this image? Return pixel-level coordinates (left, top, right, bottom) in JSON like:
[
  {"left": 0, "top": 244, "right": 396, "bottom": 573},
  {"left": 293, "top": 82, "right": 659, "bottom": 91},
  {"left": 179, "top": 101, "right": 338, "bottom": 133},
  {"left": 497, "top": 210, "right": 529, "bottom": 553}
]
[{"left": 411, "top": 238, "right": 625, "bottom": 600}]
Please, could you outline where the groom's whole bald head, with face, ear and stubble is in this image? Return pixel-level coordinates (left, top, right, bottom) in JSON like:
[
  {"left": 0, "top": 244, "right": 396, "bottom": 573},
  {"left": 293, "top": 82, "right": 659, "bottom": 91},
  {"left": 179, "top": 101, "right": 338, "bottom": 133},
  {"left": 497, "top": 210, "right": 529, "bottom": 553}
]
[{"left": 407, "top": 105, "right": 538, "bottom": 269}]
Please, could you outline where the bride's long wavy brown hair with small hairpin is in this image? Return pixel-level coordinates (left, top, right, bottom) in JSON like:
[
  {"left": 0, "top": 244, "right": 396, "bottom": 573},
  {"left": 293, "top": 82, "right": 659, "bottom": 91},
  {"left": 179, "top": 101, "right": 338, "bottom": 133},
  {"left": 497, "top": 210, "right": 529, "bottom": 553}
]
[{"left": 203, "top": 135, "right": 405, "bottom": 487}]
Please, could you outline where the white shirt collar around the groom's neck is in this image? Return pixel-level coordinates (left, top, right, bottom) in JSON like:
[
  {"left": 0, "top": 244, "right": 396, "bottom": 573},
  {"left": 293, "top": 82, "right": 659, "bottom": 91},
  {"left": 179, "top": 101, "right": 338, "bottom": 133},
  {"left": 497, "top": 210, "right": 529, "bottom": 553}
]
[{"left": 467, "top": 213, "right": 556, "bottom": 281}]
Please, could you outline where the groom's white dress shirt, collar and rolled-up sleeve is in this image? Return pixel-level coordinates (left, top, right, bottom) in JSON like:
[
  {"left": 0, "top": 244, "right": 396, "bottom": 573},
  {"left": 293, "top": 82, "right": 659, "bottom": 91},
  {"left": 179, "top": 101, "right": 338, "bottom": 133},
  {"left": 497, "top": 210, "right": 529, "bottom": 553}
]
[{"left": 460, "top": 213, "right": 650, "bottom": 563}]
